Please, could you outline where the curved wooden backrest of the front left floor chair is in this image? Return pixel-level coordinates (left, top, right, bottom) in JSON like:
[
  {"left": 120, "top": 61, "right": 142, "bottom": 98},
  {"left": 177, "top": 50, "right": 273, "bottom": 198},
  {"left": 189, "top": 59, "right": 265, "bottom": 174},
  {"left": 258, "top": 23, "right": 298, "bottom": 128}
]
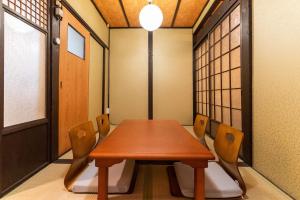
[{"left": 64, "top": 121, "right": 96, "bottom": 191}]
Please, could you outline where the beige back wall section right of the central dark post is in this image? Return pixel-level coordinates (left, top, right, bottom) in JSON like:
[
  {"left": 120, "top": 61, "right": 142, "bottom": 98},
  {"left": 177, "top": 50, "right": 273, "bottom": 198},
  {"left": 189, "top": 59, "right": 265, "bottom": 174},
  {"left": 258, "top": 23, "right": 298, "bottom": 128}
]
[{"left": 153, "top": 29, "right": 193, "bottom": 125}]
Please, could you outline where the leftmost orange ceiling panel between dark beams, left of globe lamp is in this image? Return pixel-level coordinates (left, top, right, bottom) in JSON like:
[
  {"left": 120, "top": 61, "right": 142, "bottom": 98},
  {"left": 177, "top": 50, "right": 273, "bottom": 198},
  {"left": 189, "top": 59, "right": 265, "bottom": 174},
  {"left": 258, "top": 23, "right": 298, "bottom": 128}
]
[{"left": 93, "top": 0, "right": 127, "bottom": 27}]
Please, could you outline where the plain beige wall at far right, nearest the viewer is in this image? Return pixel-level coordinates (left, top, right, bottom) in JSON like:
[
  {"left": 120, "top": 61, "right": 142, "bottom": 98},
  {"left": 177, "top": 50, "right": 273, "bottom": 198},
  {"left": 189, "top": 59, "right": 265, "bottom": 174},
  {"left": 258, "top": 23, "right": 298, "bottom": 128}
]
[{"left": 253, "top": 0, "right": 300, "bottom": 199}]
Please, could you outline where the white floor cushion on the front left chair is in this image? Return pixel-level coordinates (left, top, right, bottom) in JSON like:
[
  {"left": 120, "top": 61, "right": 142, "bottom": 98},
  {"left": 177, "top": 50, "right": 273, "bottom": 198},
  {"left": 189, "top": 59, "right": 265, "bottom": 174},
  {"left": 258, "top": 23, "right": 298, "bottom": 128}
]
[{"left": 72, "top": 160, "right": 135, "bottom": 193}]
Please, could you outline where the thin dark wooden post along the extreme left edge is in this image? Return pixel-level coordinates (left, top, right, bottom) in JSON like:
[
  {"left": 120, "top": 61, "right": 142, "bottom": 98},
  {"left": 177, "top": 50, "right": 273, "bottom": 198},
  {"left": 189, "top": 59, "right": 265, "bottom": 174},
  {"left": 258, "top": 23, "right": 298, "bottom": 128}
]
[{"left": 0, "top": 3, "right": 4, "bottom": 192}]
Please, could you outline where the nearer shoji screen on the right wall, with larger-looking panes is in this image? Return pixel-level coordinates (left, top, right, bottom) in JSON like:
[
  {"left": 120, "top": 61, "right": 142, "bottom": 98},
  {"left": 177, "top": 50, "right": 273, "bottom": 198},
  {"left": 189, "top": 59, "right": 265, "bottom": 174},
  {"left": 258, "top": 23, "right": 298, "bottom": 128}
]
[{"left": 209, "top": 6, "right": 242, "bottom": 135}]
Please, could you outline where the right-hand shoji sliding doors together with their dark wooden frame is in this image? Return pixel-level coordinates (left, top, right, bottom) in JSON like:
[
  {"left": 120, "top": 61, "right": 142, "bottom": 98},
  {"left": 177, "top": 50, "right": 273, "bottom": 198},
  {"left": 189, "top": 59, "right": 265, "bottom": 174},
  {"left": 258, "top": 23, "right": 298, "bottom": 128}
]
[{"left": 194, "top": 0, "right": 252, "bottom": 164}]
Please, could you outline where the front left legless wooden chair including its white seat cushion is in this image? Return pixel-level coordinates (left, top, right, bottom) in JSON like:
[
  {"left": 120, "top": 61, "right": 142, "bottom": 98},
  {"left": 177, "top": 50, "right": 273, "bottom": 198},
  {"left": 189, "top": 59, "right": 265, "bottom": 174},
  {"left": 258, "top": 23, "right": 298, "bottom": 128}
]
[{"left": 64, "top": 118, "right": 136, "bottom": 194}]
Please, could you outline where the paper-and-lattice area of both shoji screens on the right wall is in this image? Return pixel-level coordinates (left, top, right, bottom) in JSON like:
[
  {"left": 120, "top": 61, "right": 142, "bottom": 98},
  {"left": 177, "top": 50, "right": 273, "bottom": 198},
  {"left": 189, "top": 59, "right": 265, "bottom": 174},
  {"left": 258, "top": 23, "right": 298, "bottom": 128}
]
[{"left": 194, "top": 6, "right": 242, "bottom": 141}]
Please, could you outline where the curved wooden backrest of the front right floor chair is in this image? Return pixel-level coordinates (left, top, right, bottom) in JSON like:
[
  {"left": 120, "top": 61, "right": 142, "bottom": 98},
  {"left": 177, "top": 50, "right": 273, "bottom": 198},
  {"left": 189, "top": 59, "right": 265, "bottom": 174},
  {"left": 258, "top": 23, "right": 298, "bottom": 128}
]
[{"left": 214, "top": 124, "right": 246, "bottom": 195}]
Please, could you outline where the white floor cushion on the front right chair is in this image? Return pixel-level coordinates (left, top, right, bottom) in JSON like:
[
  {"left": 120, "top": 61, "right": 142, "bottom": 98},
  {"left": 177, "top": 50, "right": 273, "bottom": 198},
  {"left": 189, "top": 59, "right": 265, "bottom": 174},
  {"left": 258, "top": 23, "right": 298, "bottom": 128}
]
[{"left": 174, "top": 162, "right": 243, "bottom": 198}]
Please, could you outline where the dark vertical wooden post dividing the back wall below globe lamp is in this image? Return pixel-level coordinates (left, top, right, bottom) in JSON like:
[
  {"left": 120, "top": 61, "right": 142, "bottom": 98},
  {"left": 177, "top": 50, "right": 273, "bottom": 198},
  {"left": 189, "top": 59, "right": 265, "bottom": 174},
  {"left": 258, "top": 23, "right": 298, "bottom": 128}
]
[{"left": 148, "top": 31, "right": 153, "bottom": 119}]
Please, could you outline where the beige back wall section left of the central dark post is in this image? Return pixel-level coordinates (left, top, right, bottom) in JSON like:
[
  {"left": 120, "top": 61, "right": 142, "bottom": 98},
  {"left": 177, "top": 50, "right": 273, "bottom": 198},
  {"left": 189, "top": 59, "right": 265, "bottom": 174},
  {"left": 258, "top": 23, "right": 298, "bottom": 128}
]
[{"left": 110, "top": 29, "right": 148, "bottom": 124}]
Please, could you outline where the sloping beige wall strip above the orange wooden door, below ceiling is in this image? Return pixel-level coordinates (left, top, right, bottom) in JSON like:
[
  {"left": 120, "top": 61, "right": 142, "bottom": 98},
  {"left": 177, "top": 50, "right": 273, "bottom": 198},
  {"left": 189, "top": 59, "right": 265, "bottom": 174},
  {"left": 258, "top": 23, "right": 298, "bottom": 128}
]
[{"left": 67, "top": 0, "right": 108, "bottom": 44}]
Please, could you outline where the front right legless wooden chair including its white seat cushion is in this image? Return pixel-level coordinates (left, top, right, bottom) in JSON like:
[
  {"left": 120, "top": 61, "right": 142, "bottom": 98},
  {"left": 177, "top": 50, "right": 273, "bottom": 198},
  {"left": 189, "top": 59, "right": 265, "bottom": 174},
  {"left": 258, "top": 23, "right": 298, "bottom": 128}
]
[{"left": 169, "top": 124, "right": 246, "bottom": 199}]
